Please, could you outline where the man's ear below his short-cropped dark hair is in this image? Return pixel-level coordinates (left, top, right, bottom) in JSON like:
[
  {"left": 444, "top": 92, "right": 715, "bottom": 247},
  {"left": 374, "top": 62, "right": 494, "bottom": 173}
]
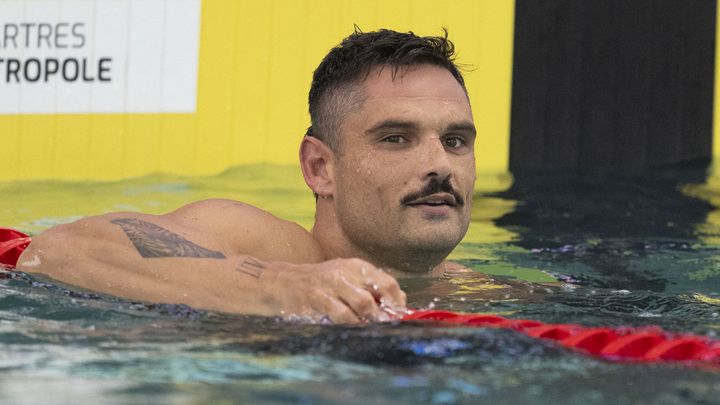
[{"left": 300, "top": 136, "right": 335, "bottom": 197}]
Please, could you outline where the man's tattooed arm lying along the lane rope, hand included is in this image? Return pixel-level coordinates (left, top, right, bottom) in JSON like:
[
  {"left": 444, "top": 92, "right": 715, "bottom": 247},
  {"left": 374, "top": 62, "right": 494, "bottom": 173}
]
[{"left": 18, "top": 215, "right": 405, "bottom": 322}]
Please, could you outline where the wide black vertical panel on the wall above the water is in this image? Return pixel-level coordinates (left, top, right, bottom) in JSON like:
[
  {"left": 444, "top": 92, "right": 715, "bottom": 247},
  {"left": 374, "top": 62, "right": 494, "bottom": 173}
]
[{"left": 510, "top": 0, "right": 716, "bottom": 171}]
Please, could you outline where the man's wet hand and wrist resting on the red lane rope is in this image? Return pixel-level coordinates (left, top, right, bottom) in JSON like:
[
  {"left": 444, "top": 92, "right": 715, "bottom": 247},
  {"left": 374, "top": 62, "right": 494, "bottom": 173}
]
[{"left": 256, "top": 259, "right": 407, "bottom": 323}]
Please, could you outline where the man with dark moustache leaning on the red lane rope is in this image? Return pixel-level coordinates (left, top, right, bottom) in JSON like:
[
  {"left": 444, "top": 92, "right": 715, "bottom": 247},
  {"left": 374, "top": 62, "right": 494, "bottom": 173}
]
[{"left": 18, "top": 30, "right": 476, "bottom": 323}]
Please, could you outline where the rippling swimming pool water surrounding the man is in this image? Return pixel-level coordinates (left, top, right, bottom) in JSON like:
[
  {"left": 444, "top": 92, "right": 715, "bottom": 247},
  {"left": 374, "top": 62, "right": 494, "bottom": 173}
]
[{"left": 0, "top": 166, "right": 720, "bottom": 404}]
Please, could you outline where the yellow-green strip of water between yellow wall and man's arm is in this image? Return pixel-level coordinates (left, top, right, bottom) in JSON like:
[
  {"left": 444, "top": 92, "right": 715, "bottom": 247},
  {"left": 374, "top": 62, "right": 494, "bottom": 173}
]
[{"left": 0, "top": 165, "right": 314, "bottom": 233}]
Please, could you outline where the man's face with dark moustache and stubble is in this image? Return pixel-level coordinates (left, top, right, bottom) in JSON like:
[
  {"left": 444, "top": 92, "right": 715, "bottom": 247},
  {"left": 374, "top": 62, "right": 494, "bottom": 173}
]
[{"left": 334, "top": 65, "right": 475, "bottom": 270}]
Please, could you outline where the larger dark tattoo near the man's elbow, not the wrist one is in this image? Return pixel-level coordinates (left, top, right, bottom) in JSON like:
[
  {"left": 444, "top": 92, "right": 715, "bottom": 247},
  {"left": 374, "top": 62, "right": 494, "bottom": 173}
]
[{"left": 110, "top": 218, "right": 225, "bottom": 259}]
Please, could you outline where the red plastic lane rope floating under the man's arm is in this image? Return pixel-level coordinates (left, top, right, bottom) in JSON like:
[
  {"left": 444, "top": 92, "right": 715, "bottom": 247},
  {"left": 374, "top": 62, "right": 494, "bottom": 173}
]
[{"left": 0, "top": 228, "right": 720, "bottom": 370}]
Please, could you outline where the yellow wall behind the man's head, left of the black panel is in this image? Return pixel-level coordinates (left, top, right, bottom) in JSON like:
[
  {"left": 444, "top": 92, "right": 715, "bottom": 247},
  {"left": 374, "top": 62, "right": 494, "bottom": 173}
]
[{"left": 0, "top": 0, "right": 514, "bottom": 180}]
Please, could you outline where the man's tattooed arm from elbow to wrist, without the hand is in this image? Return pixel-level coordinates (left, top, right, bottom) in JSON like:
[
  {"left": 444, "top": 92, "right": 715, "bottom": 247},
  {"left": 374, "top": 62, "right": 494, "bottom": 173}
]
[{"left": 18, "top": 219, "right": 284, "bottom": 315}]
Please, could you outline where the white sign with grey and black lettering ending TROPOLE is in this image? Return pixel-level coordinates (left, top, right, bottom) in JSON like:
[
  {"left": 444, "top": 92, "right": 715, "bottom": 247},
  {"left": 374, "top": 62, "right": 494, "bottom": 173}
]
[{"left": 0, "top": 0, "right": 200, "bottom": 114}]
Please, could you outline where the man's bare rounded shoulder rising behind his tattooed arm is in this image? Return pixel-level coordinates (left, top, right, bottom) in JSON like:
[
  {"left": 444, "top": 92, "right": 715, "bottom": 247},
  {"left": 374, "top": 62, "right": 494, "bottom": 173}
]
[{"left": 165, "top": 199, "right": 323, "bottom": 263}]
